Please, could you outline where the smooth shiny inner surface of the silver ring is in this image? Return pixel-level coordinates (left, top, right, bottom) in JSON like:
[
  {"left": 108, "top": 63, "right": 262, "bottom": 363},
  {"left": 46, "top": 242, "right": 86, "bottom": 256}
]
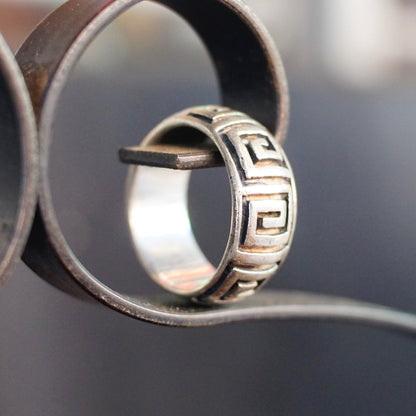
[{"left": 128, "top": 127, "right": 229, "bottom": 294}]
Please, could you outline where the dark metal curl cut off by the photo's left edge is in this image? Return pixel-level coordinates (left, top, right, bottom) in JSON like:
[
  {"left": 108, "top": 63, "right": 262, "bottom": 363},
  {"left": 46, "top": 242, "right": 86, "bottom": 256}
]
[{"left": 0, "top": 35, "right": 38, "bottom": 285}]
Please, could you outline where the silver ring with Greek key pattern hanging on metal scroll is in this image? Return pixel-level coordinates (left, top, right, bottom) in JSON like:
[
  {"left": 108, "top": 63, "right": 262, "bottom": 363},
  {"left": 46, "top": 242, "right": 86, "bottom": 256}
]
[{"left": 127, "top": 106, "right": 297, "bottom": 304}]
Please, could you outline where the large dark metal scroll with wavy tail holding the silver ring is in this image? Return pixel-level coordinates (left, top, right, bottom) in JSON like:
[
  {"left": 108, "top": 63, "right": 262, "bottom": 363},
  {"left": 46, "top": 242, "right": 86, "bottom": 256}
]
[{"left": 17, "top": 0, "right": 416, "bottom": 334}]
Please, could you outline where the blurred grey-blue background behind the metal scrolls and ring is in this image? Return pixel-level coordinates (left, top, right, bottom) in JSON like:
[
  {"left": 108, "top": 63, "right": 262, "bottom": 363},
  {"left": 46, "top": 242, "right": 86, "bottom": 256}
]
[{"left": 0, "top": 0, "right": 416, "bottom": 416}]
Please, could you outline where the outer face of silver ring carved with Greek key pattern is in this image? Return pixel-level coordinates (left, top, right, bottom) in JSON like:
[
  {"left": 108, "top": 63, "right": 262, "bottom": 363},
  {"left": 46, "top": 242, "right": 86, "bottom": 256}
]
[{"left": 186, "top": 106, "right": 296, "bottom": 303}]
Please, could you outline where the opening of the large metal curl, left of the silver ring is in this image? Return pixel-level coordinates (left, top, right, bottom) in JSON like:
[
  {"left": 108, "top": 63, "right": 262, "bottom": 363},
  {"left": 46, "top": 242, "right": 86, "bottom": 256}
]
[{"left": 49, "top": 1, "right": 220, "bottom": 294}]
